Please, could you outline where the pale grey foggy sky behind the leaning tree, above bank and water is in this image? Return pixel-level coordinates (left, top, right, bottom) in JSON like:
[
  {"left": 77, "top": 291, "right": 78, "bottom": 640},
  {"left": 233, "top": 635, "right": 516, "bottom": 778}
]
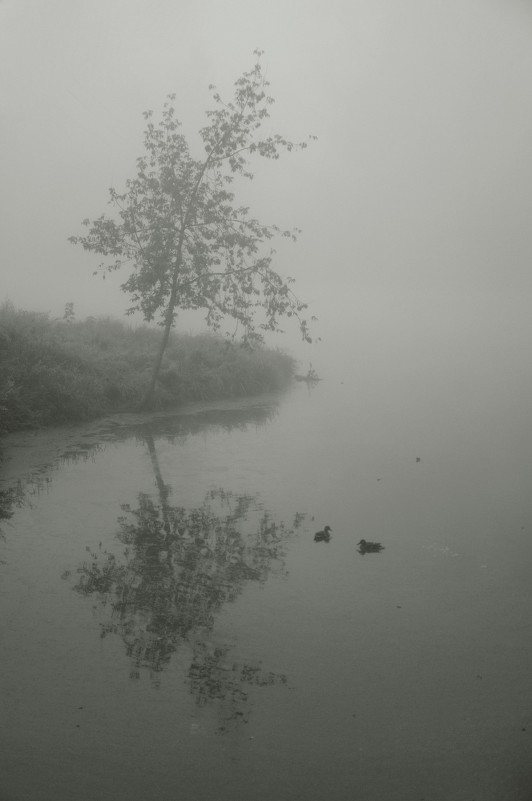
[{"left": 0, "top": 0, "right": 532, "bottom": 362}]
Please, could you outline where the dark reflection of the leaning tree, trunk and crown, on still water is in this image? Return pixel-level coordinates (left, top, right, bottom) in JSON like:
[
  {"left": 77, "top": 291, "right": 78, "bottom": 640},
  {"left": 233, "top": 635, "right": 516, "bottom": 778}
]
[{"left": 70, "top": 468, "right": 304, "bottom": 733}]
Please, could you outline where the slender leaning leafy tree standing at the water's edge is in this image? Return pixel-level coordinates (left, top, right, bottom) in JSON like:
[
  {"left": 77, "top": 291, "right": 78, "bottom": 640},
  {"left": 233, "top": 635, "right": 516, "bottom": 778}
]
[{"left": 70, "top": 50, "right": 315, "bottom": 406}]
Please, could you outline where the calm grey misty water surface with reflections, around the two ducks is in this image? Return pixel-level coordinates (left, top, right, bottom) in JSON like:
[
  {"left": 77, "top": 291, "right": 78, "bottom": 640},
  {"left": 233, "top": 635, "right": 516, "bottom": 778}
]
[{"left": 0, "top": 334, "right": 532, "bottom": 801}]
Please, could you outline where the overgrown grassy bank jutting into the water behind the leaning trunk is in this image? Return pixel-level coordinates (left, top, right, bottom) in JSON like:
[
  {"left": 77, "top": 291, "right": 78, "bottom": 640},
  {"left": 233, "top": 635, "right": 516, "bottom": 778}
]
[{"left": 0, "top": 303, "right": 295, "bottom": 434}]
